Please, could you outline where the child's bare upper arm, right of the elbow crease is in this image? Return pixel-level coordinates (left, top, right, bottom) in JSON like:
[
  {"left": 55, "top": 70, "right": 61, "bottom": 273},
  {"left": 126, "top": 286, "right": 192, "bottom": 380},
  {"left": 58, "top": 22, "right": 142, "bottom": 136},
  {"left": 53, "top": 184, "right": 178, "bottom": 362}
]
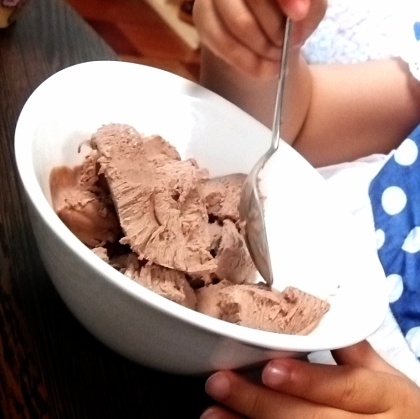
[{"left": 296, "top": 59, "right": 420, "bottom": 166}]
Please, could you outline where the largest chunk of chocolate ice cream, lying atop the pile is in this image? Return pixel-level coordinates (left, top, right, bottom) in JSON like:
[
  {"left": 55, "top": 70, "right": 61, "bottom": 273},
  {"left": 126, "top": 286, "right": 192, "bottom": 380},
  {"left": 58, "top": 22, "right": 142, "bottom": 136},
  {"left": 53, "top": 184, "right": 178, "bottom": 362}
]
[{"left": 92, "top": 124, "right": 215, "bottom": 272}]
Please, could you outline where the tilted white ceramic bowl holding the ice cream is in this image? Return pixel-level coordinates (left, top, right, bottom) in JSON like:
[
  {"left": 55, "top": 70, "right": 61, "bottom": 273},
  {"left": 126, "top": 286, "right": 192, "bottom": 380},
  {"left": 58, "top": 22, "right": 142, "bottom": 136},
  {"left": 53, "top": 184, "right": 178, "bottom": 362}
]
[{"left": 15, "top": 62, "right": 387, "bottom": 374}]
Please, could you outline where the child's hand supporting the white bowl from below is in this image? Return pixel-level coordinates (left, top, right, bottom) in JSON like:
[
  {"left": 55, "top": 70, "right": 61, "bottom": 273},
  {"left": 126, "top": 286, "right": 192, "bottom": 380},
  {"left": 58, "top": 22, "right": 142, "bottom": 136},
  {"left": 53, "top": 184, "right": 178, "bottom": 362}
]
[{"left": 202, "top": 342, "right": 420, "bottom": 419}]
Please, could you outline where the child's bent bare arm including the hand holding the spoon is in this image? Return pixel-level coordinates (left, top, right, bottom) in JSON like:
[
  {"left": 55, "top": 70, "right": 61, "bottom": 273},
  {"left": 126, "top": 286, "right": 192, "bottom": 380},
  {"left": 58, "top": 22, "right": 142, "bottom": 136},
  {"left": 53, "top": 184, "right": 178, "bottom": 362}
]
[{"left": 194, "top": 0, "right": 420, "bottom": 166}]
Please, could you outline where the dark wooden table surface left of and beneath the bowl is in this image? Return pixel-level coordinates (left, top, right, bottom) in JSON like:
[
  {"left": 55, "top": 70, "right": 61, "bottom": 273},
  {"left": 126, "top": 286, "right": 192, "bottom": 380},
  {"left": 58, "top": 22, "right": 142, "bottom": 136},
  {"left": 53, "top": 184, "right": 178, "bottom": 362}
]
[{"left": 0, "top": 0, "right": 210, "bottom": 419}]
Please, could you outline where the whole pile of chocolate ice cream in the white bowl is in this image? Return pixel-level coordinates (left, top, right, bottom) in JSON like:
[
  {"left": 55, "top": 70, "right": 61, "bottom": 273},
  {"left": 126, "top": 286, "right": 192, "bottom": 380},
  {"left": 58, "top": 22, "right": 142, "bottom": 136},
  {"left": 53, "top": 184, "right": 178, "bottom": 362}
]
[{"left": 50, "top": 124, "right": 329, "bottom": 334}]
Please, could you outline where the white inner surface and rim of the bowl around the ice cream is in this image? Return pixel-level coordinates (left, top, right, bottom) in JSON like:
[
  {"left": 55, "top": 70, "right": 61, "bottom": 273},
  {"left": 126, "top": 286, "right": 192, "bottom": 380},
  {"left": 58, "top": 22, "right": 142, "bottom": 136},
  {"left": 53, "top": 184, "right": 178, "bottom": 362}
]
[{"left": 15, "top": 61, "right": 387, "bottom": 352}]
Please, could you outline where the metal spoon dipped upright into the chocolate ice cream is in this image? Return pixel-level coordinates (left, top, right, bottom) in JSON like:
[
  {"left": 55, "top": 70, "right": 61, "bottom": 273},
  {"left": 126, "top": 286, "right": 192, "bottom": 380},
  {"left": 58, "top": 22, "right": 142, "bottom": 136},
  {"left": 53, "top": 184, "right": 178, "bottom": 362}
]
[{"left": 239, "top": 18, "right": 291, "bottom": 287}]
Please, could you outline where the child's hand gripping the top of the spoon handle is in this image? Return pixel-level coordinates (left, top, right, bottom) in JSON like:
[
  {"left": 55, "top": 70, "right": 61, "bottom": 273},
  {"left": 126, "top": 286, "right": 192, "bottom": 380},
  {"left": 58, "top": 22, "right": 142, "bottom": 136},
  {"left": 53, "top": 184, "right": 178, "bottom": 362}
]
[{"left": 193, "top": 0, "right": 327, "bottom": 79}]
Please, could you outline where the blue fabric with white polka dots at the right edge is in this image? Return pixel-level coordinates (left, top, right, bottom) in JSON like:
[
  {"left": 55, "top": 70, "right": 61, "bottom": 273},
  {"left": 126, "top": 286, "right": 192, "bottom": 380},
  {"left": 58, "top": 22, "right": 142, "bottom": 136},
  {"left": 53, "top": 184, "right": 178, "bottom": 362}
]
[{"left": 369, "top": 22, "right": 420, "bottom": 359}]
